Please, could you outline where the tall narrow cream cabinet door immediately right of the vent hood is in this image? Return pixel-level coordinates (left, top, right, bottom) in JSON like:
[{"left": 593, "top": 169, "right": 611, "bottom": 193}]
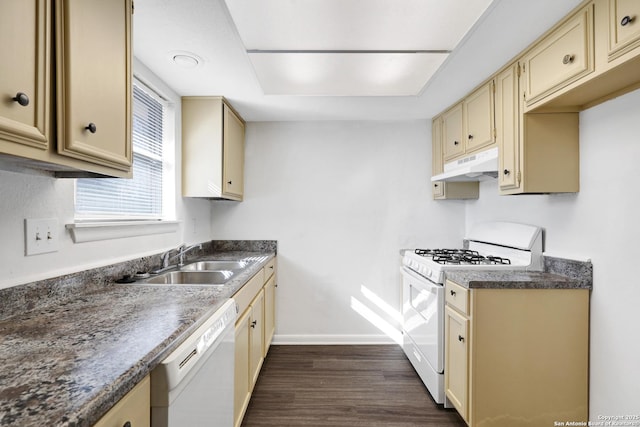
[{"left": 496, "top": 64, "right": 520, "bottom": 190}]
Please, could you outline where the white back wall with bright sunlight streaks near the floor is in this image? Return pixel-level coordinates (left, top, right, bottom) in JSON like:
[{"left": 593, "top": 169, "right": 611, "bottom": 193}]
[{"left": 212, "top": 120, "right": 464, "bottom": 342}]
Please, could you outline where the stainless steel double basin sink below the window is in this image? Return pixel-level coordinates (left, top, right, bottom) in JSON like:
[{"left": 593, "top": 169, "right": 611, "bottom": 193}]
[{"left": 138, "top": 258, "right": 259, "bottom": 286}]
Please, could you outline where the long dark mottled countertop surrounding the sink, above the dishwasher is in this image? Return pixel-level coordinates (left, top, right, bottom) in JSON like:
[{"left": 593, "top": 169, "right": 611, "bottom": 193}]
[{"left": 0, "top": 247, "right": 275, "bottom": 427}]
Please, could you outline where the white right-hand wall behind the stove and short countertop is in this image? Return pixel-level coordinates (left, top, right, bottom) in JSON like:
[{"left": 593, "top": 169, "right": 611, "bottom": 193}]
[{"left": 466, "top": 91, "right": 640, "bottom": 421}]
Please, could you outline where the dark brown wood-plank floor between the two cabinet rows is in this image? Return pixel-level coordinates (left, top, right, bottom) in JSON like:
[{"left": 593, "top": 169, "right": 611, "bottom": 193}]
[{"left": 242, "top": 345, "right": 466, "bottom": 427}]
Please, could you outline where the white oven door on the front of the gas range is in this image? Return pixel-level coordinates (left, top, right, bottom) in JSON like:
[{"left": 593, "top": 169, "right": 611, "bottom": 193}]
[{"left": 402, "top": 266, "right": 444, "bottom": 374}]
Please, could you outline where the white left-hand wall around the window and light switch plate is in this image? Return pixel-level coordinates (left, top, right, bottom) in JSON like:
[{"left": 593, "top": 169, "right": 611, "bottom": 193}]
[{"left": 0, "top": 62, "right": 211, "bottom": 288}]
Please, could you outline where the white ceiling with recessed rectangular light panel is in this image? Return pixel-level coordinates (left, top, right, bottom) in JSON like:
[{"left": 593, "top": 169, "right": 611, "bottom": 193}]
[{"left": 134, "top": 0, "right": 580, "bottom": 121}]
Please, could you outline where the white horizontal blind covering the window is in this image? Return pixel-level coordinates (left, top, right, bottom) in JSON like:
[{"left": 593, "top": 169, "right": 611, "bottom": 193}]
[{"left": 75, "top": 81, "right": 167, "bottom": 220}]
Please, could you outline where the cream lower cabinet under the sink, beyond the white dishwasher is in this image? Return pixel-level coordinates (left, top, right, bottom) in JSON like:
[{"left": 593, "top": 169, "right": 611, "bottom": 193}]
[{"left": 233, "top": 258, "right": 276, "bottom": 427}]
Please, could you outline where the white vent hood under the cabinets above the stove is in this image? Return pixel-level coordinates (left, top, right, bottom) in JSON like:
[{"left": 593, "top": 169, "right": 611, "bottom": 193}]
[{"left": 431, "top": 147, "right": 498, "bottom": 182}]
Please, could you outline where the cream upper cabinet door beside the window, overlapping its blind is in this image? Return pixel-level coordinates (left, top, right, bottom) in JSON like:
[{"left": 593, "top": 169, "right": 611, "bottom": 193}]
[{"left": 55, "top": 0, "right": 132, "bottom": 171}]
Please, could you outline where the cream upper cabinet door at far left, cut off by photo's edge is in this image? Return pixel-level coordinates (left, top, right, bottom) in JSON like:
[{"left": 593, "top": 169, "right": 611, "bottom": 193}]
[{"left": 0, "top": 0, "right": 51, "bottom": 155}]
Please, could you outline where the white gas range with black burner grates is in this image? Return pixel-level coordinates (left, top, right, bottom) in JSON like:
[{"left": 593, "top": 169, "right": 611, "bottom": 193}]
[{"left": 401, "top": 222, "right": 543, "bottom": 407}]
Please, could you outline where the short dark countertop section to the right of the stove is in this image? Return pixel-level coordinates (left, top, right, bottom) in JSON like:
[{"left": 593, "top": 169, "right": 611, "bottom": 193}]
[{"left": 445, "top": 270, "right": 591, "bottom": 289}]
